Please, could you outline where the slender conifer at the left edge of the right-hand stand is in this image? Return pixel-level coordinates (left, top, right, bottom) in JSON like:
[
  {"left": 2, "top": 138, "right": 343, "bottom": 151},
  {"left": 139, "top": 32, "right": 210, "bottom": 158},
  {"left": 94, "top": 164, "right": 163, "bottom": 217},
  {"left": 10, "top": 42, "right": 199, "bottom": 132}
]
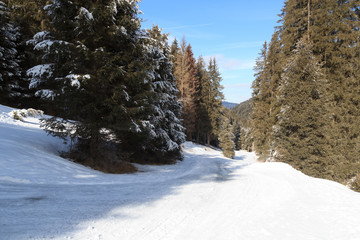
[{"left": 252, "top": 31, "right": 282, "bottom": 160}]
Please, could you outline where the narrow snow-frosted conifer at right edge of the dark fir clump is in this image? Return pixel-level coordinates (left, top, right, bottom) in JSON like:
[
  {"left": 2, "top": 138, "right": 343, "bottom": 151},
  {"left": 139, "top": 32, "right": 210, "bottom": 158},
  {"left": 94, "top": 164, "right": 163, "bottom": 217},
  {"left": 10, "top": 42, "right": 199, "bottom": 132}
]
[{"left": 139, "top": 26, "right": 185, "bottom": 163}]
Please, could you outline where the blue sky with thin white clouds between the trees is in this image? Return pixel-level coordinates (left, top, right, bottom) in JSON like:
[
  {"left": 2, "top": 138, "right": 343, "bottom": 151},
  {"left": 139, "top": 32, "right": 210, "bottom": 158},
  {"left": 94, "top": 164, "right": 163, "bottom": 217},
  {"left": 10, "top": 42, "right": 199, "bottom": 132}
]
[{"left": 139, "top": 0, "right": 284, "bottom": 103}]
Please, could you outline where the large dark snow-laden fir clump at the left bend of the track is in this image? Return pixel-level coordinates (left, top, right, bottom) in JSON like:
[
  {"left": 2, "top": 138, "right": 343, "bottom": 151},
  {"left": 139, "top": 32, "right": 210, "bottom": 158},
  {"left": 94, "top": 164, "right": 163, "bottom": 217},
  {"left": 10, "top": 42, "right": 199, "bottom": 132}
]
[{"left": 28, "top": 0, "right": 184, "bottom": 167}]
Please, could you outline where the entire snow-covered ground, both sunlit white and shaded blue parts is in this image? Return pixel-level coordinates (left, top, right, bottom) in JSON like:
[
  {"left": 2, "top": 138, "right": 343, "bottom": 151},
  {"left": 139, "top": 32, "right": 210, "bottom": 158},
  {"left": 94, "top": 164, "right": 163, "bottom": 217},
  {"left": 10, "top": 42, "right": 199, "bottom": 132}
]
[{"left": 0, "top": 105, "right": 360, "bottom": 240}]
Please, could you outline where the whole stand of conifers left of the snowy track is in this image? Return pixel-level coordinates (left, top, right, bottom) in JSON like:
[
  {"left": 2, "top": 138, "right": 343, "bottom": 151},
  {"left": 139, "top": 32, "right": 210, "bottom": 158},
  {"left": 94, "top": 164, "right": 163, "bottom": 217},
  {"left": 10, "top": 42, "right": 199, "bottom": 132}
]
[{"left": 0, "top": 0, "right": 234, "bottom": 171}]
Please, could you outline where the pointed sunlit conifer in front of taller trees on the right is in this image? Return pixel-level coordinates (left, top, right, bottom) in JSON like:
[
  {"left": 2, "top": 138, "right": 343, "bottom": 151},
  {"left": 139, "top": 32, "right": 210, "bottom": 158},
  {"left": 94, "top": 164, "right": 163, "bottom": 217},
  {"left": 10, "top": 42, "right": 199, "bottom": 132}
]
[{"left": 275, "top": 40, "right": 331, "bottom": 178}]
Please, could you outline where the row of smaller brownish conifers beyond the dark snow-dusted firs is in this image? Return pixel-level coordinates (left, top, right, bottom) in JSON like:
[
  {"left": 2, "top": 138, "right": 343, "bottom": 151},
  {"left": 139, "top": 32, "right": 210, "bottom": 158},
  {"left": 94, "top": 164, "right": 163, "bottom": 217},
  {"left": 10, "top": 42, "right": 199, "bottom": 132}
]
[{"left": 171, "top": 38, "right": 235, "bottom": 158}]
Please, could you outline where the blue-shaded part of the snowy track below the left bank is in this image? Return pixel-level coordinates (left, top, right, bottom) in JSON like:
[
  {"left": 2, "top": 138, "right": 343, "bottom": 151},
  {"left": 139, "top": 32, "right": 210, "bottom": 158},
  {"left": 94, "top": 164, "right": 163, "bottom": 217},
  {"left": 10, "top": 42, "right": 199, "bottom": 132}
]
[{"left": 0, "top": 143, "right": 252, "bottom": 239}]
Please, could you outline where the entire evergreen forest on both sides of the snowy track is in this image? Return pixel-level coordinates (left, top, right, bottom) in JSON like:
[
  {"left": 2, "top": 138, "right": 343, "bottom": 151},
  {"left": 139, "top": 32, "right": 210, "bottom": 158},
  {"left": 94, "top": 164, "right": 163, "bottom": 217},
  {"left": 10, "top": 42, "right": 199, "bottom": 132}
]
[{"left": 0, "top": 0, "right": 360, "bottom": 191}]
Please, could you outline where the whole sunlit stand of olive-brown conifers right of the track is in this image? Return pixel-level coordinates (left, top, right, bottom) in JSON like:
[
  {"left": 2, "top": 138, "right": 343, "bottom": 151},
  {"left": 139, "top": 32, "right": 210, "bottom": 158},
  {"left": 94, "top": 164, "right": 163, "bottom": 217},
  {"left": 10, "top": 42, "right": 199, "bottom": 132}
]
[{"left": 252, "top": 0, "right": 360, "bottom": 190}]
